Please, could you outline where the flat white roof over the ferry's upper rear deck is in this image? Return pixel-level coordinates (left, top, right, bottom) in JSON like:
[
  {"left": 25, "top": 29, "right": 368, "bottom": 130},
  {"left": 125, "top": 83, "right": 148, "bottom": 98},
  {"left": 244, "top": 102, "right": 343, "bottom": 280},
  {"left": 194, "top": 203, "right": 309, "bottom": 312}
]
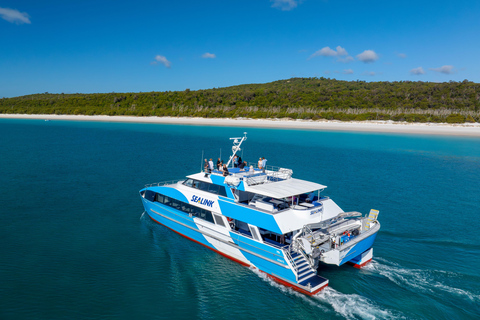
[{"left": 245, "top": 178, "right": 327, "bottom": 199}]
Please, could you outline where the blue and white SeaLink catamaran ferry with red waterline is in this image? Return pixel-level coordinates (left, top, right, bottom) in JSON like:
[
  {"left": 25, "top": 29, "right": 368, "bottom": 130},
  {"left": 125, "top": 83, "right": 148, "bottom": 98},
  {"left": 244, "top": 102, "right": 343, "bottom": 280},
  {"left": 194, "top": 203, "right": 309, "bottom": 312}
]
[{"left": 140, "top": 133, "right": 380, "bottom": 295}]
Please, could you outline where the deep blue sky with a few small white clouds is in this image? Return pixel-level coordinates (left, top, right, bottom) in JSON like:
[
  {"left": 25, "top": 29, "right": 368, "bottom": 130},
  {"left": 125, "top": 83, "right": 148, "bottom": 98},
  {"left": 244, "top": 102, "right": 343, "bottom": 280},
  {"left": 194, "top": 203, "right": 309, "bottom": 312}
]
[{"left": 0, "top": 0, "right": 480, "bottom": 98}]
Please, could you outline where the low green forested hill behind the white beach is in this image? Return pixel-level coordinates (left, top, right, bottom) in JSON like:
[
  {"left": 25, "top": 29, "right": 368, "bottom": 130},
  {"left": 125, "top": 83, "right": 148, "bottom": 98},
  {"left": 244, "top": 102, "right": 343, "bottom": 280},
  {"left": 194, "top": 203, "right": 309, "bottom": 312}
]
[{"left": 0, "top": 77, "right": 480, "bottom": 123}]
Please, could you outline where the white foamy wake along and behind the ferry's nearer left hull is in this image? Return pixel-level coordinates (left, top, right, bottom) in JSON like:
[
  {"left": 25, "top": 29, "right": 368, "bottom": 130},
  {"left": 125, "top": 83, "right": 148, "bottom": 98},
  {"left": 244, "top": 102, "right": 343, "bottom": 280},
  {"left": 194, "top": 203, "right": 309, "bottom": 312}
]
[{"left": 250, "top": 267, "right": 406, "bottom": 319}]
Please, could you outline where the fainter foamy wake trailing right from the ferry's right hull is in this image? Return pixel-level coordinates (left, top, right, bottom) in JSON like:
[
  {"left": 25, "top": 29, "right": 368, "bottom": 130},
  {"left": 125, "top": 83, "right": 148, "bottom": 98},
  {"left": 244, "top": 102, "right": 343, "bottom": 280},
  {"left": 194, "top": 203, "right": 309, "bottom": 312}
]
[{"left": 363, "top": 258, "right": 480, "bottom": 303}]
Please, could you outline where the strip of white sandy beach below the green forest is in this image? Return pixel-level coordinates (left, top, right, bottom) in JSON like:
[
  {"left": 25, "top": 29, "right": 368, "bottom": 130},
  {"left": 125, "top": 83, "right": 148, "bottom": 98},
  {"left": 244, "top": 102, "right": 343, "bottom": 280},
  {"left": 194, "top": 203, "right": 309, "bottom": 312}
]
[{"left": 0, "top": 114, "right": 480, "bottom": 137}]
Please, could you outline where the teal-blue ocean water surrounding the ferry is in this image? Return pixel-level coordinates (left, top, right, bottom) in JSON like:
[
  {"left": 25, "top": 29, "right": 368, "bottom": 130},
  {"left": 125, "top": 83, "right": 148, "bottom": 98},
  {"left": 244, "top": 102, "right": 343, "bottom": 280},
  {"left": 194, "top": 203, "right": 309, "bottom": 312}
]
[{"left": 0, "top": 119, "right": 480, "bottom": 320}]
